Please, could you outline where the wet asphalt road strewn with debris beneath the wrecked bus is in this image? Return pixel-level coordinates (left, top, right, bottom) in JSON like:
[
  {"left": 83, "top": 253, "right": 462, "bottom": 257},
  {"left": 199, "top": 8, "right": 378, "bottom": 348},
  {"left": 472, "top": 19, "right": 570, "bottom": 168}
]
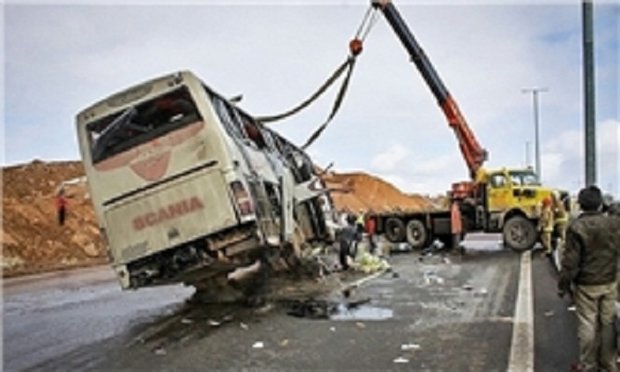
[{"left": 3, "top": 236, "right": 577, "bottom": 371}]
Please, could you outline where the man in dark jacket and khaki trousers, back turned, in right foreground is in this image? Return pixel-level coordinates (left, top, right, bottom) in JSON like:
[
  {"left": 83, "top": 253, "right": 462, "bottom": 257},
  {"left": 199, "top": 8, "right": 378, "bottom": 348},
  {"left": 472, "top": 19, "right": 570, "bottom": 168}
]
[{"left": 558, "top": 186, "right": 620, "bottom": 371}]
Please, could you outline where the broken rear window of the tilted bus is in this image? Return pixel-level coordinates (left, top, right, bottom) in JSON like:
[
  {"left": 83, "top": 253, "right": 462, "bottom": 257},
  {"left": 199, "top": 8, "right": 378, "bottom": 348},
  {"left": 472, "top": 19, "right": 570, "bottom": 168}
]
[{"left": 86, "top": 87, "right": 202, "bottom": 163}]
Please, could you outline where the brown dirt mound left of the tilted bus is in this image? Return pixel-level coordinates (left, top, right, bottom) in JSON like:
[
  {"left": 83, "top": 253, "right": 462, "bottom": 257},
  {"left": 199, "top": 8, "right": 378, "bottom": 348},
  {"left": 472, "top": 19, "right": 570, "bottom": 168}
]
[{"left": 0, "top": 160, "right": 106, "bottom": 276}]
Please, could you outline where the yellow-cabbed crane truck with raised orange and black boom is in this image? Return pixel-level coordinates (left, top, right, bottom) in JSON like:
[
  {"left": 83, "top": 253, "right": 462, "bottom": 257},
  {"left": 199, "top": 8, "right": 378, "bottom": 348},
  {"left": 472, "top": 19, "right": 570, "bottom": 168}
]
[{"left": 364, "top": 0, "right": 567, "bottom": 250}]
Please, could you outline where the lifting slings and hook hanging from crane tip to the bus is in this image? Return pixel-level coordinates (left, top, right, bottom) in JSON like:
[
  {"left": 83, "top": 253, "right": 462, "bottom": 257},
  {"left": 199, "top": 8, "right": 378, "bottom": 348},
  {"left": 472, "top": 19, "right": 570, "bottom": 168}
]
[{"left": 256, "top": 6, "right": 377, "bottom": 150}]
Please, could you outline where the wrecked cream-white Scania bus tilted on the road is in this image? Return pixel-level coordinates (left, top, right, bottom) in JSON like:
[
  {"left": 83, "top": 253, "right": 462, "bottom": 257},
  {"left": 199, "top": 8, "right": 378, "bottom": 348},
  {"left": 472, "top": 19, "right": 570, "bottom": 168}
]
[{"left": 76, "top": 71, "right": 331, "bottom": 288}]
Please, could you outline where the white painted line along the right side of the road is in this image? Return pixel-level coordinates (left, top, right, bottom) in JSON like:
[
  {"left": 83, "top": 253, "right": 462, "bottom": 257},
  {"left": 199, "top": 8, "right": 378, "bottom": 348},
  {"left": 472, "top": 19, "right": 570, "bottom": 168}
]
[{"left": 508, "top": 251, "right": 534, "bottom": 372}]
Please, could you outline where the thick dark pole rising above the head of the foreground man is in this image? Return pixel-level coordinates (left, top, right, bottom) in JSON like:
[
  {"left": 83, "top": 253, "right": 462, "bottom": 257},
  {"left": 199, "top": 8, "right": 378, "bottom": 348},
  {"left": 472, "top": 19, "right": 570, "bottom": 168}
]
[{"left": 582, "top": 0, "right": 596, "bottom": 186}]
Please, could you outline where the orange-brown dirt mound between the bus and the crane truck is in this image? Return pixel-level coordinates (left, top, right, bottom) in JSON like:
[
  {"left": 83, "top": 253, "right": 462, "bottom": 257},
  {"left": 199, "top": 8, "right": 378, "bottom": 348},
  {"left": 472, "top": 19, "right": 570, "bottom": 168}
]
[{"left": 322, "top": 172, "right": 435, "bottom": 213}]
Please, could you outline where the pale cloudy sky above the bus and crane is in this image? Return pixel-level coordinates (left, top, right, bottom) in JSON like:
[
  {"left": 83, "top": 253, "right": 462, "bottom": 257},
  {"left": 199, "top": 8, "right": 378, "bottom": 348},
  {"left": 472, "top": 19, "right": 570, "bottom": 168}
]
[{"left": 0, "top": 0, "right": 620, "bottom": 198}]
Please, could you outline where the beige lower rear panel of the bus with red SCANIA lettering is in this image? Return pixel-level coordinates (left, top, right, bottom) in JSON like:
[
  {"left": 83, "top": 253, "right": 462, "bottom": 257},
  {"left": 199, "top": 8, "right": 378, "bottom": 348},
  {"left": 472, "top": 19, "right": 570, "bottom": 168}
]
[{"left": 105, "top": 170, "right": 238, "bottom": 263}]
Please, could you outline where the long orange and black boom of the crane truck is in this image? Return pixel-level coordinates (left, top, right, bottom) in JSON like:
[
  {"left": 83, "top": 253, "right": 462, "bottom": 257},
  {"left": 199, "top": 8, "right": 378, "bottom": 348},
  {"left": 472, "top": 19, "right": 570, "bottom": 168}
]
[{"left": 372, "top": 0, "right": 487, "bottom": 179}]
